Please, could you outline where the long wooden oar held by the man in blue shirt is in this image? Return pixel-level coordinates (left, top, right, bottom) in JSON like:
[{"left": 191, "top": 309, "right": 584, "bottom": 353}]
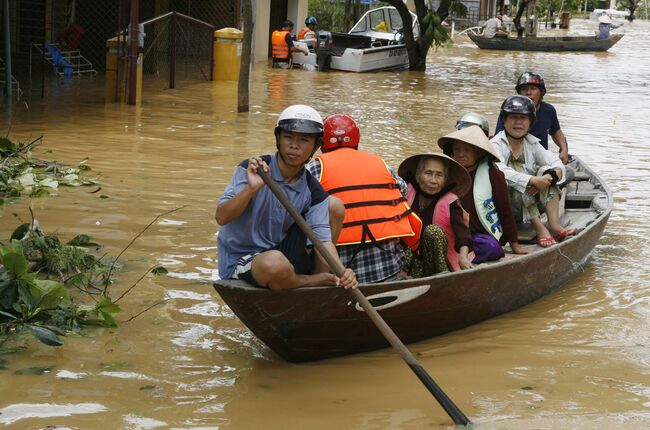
[{"left": 257, "top": 167, "right": 470, "bottom": 425}]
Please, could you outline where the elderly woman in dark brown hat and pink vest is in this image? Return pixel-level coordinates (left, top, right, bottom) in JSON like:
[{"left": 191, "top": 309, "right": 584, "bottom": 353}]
[{"left": 398, "top": 153, "right": 474, "bottom": 277}]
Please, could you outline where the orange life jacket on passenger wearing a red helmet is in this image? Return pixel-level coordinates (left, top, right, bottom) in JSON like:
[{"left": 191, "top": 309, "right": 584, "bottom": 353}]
[{"left": 318, "top": 148, "right": 422, "bottom": 251}]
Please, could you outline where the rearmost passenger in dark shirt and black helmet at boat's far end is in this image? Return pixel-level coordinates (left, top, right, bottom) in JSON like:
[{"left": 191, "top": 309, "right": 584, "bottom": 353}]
[{"left": 494, "top": 72, "right": 572, "bottom": 165}]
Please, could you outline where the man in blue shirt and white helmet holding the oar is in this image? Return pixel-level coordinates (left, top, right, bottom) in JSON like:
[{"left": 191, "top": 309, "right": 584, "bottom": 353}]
[{"left": 215, "top": 105, "right": 358, "bottom": 290}]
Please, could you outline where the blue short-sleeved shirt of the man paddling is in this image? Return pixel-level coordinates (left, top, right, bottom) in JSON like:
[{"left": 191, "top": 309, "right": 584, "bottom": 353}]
[{"left": 217, "top": 155, "right": 332, "bottom": 279}]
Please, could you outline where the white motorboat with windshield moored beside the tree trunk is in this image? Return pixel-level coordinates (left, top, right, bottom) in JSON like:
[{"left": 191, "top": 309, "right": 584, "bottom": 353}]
[{"left": 292, "top": 6, "right": 420, "bottom": 72}]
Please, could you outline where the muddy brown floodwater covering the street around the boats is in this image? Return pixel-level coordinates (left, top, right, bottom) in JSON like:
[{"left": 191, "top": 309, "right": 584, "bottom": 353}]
[{"left": 0, "top": 19, "right": 650, "bottom": 429}]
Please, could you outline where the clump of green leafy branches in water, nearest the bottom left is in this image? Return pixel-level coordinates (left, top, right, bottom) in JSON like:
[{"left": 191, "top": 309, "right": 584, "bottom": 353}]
[{"left": 0, "top": 228, "right": 120, "bottom": 351}]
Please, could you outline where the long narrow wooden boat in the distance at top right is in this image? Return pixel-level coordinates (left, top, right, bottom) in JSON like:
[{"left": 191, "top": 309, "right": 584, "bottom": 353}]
[{"left": 468, "top": 33, "right": 623, "bottom": 51}]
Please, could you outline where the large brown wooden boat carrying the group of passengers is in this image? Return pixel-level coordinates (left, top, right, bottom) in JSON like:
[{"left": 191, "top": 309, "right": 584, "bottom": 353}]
[{"left": 214, "top": 159, "right": 612, "bottom": 362}]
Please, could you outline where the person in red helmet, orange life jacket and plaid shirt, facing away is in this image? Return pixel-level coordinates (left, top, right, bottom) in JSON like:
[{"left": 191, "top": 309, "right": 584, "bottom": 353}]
[{"left": 307, "top": 114, "right": 422, "bottom": 283}]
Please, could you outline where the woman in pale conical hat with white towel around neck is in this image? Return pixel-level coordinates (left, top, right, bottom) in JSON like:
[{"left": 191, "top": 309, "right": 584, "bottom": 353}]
[{"left": 438, "top": 125, "right": 528, "bottom": 264}]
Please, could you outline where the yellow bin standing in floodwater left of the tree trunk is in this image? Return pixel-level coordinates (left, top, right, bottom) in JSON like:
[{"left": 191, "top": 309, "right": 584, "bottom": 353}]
[{"left": 212, "top": 27, "right": 244, "bottom": 81}]
